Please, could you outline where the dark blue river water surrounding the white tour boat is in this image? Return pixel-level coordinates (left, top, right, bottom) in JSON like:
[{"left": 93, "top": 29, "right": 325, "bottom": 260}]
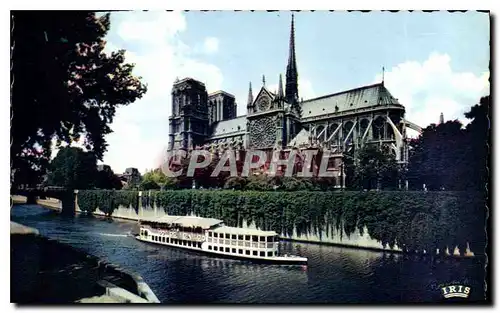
[{"left": 11, "top": 205, "right": 485, "bottom": 304}]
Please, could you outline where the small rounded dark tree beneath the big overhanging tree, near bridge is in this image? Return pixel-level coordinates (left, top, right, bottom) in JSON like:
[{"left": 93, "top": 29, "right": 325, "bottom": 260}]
[{"left": 48, "top": 147, "right": 97, "bottom": 189}]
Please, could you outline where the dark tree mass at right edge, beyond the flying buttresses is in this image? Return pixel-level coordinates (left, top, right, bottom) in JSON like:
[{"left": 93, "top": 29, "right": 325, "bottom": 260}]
[{"left": 408, "top": 96, "right": 491, "bottom": 191}]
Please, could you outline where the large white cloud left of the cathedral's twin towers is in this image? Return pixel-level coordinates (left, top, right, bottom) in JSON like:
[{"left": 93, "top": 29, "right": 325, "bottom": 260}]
[{"left": 97, "top": 12, "right": 223, "bottom": 173}]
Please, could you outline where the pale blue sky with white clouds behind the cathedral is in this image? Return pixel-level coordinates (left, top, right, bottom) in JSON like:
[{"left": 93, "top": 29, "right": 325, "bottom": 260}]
[{"left": 78, "top": 11, "right": 490, "bottom": 173}]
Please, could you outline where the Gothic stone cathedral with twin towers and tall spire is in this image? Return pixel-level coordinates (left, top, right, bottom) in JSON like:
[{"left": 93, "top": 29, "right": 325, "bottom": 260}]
[{"left": 168, "top": 16, "right": 421, "bottom": 183}]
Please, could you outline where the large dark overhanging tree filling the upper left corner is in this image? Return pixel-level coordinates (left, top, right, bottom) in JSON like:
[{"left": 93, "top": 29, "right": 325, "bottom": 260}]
[{"left": 11, "top": 11, "right": 147, "bottom": 188}]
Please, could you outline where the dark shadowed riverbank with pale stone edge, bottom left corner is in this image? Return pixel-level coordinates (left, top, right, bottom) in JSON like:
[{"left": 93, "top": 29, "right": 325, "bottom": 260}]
[{"left": 10, "top": 222, "right": 159, "bottom": 304}]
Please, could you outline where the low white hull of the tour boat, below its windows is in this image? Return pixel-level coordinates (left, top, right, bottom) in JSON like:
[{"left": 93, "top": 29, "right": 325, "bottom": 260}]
[{"left": 135, "top": 236, "right": 307, "bottom": 265}]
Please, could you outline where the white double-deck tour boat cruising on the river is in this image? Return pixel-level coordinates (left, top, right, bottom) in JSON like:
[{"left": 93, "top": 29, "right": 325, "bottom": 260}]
[{"left": 136, "top": 216, "right": 307, "bottom": 265}]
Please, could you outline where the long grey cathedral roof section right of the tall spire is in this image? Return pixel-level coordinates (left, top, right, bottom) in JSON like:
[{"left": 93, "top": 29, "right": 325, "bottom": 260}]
[{"left": 302, "top": 83, "right": 402, "bottom": 118}]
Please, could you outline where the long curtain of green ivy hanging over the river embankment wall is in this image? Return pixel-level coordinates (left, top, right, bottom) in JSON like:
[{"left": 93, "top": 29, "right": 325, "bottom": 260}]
[{"left": 78, "top": 190, "right": 486, "bottom": 254}]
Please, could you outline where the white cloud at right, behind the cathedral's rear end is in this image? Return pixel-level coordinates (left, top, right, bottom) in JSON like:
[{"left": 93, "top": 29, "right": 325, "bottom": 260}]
[{"left": 375, "top": 53, "right": 489, "bottom": 127}]
